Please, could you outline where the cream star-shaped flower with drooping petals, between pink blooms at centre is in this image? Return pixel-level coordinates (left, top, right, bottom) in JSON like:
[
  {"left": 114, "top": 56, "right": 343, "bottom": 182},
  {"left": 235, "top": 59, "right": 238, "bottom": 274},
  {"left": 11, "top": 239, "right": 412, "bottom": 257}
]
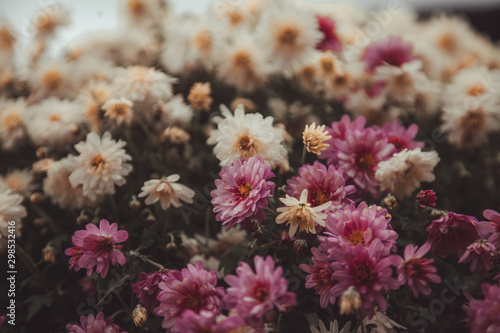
[{"left": 276, "top": 189, "right": 332, "bottom": 237}]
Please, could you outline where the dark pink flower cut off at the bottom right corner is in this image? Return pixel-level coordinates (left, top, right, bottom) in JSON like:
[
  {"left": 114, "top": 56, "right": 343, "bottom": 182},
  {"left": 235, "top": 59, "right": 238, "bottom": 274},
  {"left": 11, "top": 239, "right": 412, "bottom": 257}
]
[{"left": 466, "top": 283, "right": 500, "bottom": 333}]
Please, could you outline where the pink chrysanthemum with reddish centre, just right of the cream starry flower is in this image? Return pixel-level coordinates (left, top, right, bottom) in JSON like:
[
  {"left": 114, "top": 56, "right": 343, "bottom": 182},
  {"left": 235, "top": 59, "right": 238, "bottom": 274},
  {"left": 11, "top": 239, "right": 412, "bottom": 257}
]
[{"left": 319, "top": 201, "right": 398, "bottom": 256}]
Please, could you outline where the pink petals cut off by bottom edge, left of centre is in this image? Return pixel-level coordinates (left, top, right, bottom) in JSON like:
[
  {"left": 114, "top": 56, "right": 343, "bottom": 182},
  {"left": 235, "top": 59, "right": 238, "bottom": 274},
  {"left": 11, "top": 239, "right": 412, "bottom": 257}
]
[{"left": 176, "top": 310, "right": 245, "bottom": 333}]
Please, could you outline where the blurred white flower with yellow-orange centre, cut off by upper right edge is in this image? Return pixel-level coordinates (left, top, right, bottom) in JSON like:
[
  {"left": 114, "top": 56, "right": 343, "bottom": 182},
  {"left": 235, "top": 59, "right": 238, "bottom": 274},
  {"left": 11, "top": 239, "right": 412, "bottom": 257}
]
[{"left": 444, "top": 66, "right": 500, "bottom": 105}]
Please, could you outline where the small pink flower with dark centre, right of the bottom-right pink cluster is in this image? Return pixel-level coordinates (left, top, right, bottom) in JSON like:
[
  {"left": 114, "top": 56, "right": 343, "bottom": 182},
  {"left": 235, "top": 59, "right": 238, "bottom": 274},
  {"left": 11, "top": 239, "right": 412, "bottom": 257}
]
[{"left": 393, "top": 243, "right": 441, "bottom": 297}]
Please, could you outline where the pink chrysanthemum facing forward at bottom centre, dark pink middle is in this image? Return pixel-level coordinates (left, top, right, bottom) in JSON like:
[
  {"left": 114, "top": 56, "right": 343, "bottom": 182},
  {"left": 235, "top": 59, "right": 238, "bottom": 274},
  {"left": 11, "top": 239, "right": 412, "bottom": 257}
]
[{"left": 224, "top": 256, "right": 297, "bottom": 332}]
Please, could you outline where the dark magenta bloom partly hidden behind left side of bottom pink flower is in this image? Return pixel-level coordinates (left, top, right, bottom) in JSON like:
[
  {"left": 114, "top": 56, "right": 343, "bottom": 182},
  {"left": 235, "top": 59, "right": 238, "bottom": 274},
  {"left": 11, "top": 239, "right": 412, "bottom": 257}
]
[{"left": 132, "top": 269, "right": 167, "bottom": 313}]
